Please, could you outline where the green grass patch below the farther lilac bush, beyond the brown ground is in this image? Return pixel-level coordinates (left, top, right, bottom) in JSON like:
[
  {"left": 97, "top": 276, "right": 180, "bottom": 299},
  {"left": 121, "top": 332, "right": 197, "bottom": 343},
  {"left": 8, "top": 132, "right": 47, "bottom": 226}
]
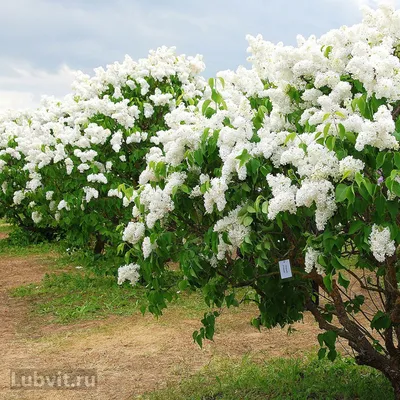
[{"left": 0, "top": 220, "right": 212, "bottom": 324}]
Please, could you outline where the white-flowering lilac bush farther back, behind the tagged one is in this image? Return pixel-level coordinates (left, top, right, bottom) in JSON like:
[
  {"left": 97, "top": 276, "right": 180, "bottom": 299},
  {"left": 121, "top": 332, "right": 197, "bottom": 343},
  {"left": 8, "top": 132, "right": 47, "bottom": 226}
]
[{"left": 0, "top": 47, "right": 205, "bottom": 248}]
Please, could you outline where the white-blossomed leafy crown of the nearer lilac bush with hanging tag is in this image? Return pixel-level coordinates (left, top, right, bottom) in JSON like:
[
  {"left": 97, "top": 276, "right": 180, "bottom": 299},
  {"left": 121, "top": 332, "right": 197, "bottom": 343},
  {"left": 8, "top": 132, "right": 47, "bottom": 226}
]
[{"left": 124, "top": 3, "right": 400, "bottom": 282}]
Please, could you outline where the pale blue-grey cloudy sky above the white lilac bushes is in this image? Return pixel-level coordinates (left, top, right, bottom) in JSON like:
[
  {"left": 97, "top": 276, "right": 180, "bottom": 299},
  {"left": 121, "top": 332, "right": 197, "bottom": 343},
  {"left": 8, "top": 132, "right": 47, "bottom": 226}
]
[{"left": 0, "top": 0, "right": 400, "bottom": 110}]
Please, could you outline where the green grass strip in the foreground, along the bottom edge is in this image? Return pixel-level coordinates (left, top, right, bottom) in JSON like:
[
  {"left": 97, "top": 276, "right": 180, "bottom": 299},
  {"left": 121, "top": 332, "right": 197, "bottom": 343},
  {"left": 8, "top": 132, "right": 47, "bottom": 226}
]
[{"left": 141, "top": 358, "right": 393, "bottom": 400}]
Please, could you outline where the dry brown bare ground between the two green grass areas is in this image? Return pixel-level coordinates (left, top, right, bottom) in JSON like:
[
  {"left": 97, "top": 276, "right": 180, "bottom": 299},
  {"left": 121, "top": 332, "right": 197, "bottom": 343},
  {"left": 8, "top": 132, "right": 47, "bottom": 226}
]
[{"left": 0, "top": 257, "right": 319, "bottom": 400}]
